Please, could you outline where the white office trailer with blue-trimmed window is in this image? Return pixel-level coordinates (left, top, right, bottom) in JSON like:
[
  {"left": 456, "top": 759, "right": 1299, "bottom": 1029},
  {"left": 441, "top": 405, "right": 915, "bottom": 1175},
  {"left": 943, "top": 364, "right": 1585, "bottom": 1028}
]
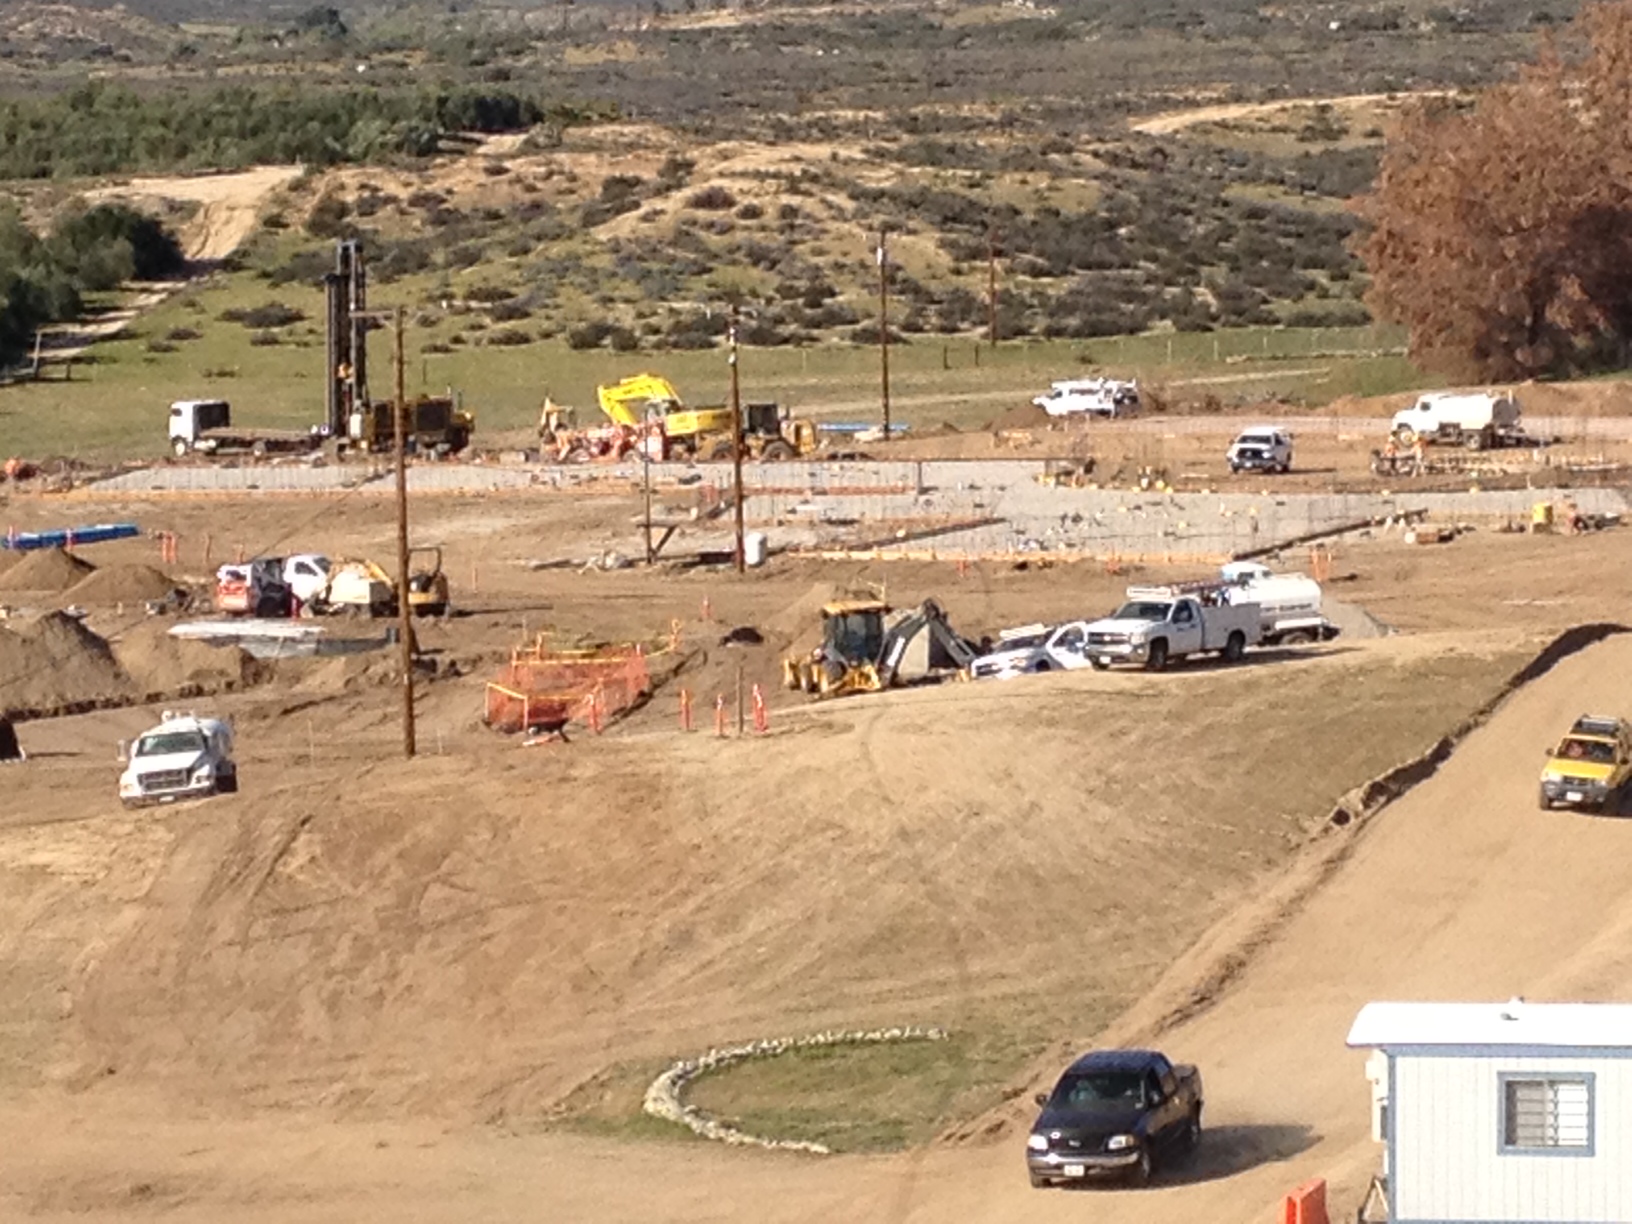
[{"left": 1348, "top": 1000, "right": 1632, "bottom": 1224}]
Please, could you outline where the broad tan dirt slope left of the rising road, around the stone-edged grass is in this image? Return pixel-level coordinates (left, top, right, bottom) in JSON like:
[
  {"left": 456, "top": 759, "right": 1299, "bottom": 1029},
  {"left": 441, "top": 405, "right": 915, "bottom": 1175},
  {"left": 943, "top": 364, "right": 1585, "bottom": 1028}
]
[{"left": 0, "top": 636, "right": 1516, "bottom": 1221}]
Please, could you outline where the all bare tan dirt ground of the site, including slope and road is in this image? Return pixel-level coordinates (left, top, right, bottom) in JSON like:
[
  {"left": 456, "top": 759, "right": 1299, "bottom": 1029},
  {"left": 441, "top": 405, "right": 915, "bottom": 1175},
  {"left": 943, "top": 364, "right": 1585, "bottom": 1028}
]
[{"left": 0, "top": 490, "right": 1632, "bottom": 1222}]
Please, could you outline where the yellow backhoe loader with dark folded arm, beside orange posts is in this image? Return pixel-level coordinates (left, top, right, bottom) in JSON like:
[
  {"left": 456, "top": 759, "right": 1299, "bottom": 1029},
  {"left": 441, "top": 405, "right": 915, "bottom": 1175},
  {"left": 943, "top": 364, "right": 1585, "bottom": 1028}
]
[{"left": 782, "top": 599, "right": 981, "bottom": 698}]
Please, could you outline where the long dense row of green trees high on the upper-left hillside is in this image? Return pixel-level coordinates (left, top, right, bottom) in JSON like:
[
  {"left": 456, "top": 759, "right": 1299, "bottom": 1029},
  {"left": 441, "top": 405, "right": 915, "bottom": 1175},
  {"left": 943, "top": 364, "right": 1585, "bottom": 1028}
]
[{"left": 0, "top": 82, "right": 604, "bottom": 180}]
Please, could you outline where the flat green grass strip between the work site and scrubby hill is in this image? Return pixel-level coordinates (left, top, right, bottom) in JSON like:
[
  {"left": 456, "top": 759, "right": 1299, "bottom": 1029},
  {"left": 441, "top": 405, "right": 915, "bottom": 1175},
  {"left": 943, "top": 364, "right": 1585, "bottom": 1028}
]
[{"left": 0, "top": 273, "right": 1423, "bottom": 460}]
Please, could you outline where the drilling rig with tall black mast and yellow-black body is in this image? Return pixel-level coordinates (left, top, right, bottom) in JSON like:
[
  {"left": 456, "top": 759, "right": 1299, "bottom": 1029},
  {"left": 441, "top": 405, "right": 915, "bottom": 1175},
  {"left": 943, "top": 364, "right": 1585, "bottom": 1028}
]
[{"left": 323, "top": 238, "right": 475, "bottom": 455}]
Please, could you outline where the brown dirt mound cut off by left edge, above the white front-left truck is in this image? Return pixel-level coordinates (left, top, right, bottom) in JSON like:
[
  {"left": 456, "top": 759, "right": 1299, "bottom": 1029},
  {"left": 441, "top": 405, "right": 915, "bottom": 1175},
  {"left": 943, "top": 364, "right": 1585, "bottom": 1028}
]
[{"left": 0, "top": 612, "right": 131, "bottom": 712}]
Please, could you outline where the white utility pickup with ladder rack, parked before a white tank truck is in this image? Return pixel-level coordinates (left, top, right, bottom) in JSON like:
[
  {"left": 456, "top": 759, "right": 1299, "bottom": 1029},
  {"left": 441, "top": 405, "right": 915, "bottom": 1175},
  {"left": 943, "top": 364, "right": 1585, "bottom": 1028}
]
[{"left": 1087, "top": 586, "right": 1263, "bottom": 671}]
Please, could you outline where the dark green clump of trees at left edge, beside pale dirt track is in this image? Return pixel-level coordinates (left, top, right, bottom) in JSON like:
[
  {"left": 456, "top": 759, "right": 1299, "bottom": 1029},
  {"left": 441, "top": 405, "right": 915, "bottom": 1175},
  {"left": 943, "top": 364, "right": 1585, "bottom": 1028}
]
[{"left": 0, "top": 204, "right": 184, "bottom": 364}]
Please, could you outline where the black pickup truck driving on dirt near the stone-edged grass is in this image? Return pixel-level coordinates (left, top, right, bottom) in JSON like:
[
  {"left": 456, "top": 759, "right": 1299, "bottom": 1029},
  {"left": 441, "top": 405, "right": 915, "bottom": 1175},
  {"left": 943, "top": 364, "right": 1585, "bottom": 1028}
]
[{"left": 1025, "top": 1049, "right": 1201, "bottom": 1186}]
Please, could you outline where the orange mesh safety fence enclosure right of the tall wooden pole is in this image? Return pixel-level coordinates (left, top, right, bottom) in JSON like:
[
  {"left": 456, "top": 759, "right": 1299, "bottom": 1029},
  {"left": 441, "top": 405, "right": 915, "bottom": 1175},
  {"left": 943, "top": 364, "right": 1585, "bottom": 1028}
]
[{"left": 481, "top": 641, "right": 651, "bottom": 733}]
